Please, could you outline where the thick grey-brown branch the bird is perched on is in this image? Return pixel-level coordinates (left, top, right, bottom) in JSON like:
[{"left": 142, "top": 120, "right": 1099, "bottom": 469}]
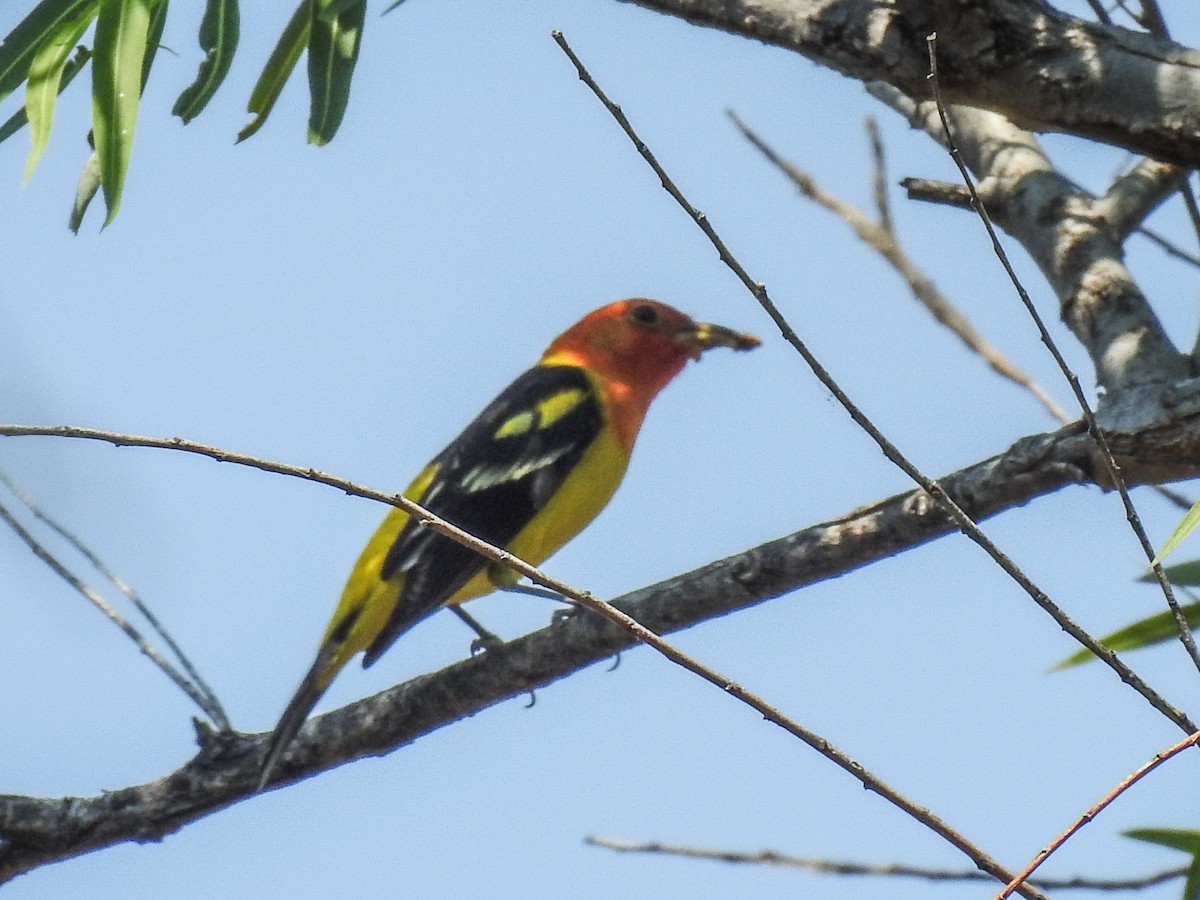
[{"left": 7, "top": 380, "right": 1200, "bottom": 881}]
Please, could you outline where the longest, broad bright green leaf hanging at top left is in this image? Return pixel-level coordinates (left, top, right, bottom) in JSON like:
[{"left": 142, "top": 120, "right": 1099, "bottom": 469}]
[{"left": 91, "top": 0, "right": 157, "bottom": 226}]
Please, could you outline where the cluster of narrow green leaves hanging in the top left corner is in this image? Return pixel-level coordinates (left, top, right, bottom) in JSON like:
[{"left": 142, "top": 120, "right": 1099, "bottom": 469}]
[{"left": 0, "top": 0, "right": 366, "bottom": 230}]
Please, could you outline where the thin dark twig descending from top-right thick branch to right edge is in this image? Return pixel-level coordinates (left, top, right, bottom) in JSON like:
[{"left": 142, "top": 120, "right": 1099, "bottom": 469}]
[{"left": 926, "top": 34, "right": 1200, "bottom": 681}]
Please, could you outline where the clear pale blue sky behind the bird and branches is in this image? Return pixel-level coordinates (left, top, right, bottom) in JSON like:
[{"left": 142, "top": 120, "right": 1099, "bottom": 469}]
[{"left": 0, "top": 0, "right": 1200, "bottom": 900}]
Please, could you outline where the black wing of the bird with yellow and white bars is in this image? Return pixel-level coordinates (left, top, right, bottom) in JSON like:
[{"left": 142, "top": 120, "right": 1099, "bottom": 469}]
[{"left": 362, "top": 366, "right": 604, "bottom": 666}]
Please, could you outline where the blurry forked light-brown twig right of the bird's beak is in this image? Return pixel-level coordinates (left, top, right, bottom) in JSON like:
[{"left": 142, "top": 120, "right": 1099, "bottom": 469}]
[{"left": 727, "top": 112, "right": 1073, "bottom": 425}]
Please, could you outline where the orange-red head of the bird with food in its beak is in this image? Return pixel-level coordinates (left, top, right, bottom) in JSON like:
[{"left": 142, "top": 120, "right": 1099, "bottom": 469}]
[{"left": 541, "top": 298, "right": 760, "bottom": 450}]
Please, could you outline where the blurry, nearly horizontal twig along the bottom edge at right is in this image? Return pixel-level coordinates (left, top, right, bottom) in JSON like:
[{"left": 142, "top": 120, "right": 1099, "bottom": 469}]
[{"left": 583, "top": 838, "right": 1188, "bottom": 890}]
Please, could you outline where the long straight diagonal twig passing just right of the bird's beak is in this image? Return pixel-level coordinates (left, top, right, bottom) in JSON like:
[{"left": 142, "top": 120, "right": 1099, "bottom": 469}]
[{"left": 549, "top": 31, "right": 1196, "bottom": 748}]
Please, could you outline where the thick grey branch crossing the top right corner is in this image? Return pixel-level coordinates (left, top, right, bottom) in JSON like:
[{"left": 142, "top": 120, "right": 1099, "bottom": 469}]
[{"left": 632, "top": 0, "right": 1200, "bottom": 167}]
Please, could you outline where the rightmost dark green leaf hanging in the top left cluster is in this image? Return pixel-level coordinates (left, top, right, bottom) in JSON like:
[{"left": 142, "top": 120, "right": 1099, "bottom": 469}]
[{"left": 308, "top": 0, "right": 367, "bottom": 146}]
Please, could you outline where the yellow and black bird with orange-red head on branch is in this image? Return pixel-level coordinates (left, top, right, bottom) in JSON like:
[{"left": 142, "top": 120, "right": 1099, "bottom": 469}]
[{"left": 259, "top": 299, "right": 758, "bottom": 790}]
